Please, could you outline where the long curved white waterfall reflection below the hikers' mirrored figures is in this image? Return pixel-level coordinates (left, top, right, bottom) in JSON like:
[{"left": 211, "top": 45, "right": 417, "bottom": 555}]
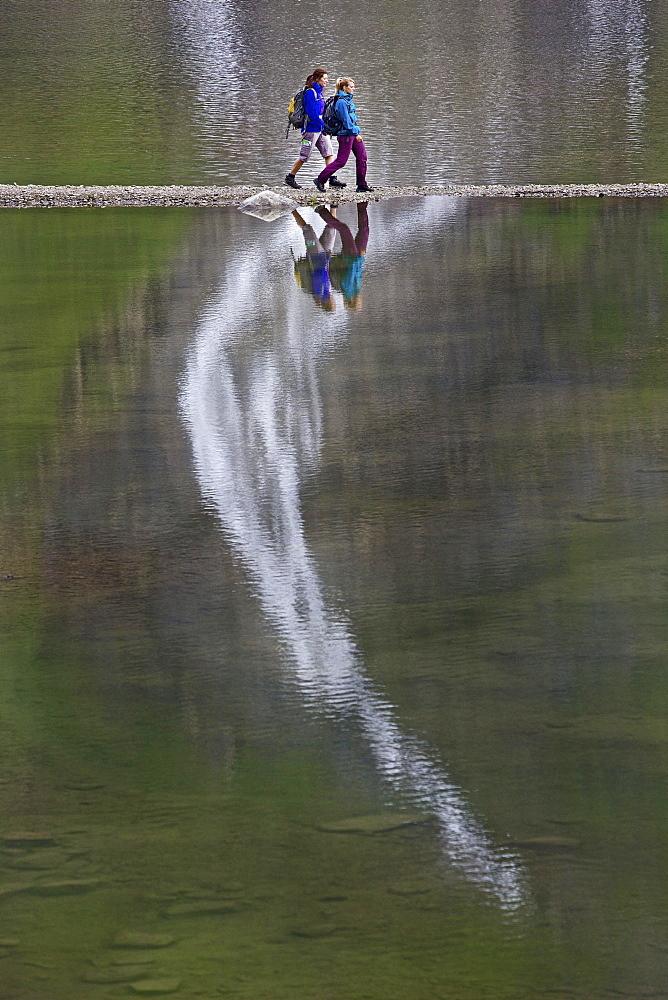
[{"left": 182, "top": 205, "right": 526, "bottom": 909}]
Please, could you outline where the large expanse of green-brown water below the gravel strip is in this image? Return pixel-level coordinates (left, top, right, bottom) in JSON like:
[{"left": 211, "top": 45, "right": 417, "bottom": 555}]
[{"left": 0, "top": 199, "right": 668, "bottom": 1000}]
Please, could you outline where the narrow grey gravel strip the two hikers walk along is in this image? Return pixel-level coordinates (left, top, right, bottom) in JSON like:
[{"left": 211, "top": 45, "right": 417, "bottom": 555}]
[{"left": 0, "top": 182, "right": 668, "bottom": 208}]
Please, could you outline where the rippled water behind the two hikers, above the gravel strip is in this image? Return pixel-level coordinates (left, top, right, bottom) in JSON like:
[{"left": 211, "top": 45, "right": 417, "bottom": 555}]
[{"left": 0, "top": 0, "right": 668, "bottom": 184}]
